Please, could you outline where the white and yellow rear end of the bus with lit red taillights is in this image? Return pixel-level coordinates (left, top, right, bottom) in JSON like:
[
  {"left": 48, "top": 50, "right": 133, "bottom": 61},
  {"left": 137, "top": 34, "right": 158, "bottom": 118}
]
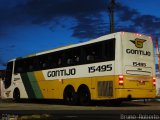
[{"left": 116, "top": 33, "right": 156, "bottom": 99}]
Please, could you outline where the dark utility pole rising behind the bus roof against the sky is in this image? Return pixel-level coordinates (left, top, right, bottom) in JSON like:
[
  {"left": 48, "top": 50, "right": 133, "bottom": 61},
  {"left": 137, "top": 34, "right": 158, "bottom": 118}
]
[{"left": 108, "top": 0, "right": 115, "bottom": 33}]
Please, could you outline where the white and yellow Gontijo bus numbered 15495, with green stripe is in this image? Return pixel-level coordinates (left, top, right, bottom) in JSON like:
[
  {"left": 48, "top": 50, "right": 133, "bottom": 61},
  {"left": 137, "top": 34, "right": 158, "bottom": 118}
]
[{"left": 4, "top": 32, "right": 156, "bottom": 105}]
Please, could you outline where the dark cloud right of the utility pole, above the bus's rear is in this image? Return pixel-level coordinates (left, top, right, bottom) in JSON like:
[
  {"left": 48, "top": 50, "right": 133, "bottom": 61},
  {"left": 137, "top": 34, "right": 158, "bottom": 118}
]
[{"left": 115, "top": 3, "right": 160, "bottom": 36}]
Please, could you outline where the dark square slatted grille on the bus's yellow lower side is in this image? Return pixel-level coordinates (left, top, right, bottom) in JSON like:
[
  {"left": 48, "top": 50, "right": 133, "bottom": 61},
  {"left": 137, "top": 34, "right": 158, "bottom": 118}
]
[{"left": 98, "top": 81, "right": 113, "bottom": 97}]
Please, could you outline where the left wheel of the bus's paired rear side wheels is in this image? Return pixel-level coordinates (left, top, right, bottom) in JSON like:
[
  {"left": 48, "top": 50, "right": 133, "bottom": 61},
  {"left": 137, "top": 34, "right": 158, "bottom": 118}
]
[{"left": 63, "top": 86, "right": 77, "bottom": 105}]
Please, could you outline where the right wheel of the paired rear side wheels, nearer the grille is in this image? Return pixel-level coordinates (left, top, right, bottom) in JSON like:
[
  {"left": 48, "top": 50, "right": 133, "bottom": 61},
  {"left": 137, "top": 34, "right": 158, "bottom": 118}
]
[{"left": 78, "top": 86, "right": 91, "bottom": 105}]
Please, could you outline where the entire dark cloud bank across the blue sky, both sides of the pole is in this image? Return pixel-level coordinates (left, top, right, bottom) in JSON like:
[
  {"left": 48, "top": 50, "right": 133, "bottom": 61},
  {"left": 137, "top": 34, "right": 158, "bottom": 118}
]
[{"left": 0, "top": 0, "right": 160, "bottom": 39}]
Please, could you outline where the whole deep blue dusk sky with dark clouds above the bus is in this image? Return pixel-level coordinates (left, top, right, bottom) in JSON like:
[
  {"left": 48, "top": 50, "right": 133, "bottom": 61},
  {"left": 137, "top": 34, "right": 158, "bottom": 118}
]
[{"left": 0, "top": 0, "right": 160, "bottom": 69}]
